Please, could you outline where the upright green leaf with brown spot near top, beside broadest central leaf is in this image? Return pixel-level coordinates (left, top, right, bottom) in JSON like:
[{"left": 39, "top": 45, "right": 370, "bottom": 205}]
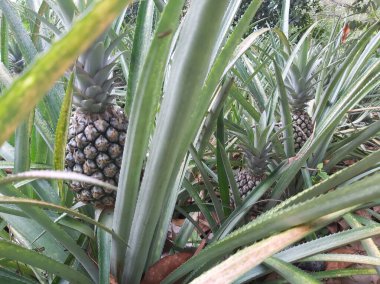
[{"left": 111, "top": 1, "right": 183, "bottom": 274}]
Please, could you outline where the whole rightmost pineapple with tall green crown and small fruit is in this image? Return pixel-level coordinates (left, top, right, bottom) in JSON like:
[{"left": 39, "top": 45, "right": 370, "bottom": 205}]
[{"left": 283, "top": 39, "right": 320, "bottom": 152}]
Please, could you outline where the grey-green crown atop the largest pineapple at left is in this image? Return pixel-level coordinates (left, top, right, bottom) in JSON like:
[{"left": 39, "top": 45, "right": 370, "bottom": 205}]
[{"left": 73, "top": 34, "right": 121, "bottom": 113}]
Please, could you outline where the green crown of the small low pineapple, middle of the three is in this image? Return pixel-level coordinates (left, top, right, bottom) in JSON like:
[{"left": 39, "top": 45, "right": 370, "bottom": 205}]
[{"left": 237, "top": 111, "right": 274, "bottom": 175}]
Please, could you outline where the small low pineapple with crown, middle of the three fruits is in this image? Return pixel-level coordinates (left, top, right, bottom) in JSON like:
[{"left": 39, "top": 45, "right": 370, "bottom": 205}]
[{"left": 230, "top": 112, "right": 274, "bottom": 214}]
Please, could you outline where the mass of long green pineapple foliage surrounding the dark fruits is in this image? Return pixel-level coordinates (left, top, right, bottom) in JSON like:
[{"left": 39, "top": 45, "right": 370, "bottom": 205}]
[{"left": 0, "top": 0, "right": 380, "bottom": 283}]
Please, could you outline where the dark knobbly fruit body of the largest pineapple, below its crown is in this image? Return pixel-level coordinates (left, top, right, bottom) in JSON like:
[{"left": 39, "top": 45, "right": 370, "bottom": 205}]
[{"left": 66, "top": 105, "right": 128, "bottom": 207}]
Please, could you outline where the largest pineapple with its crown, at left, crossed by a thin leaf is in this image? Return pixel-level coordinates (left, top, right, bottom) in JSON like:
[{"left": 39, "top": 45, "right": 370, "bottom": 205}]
[{"left": 66, "top": 36, "right": 128, "bottom": 207}]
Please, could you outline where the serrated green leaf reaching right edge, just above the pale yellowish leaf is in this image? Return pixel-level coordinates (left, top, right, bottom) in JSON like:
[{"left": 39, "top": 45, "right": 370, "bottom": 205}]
[{"left": 166, "top": 174, "right": 380, "bottom": 282}]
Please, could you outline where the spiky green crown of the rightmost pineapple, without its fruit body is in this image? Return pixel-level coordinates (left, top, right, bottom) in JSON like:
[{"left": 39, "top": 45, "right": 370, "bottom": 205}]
[{"left": 280, "top": 37, "right": 321, "bottom": 110}]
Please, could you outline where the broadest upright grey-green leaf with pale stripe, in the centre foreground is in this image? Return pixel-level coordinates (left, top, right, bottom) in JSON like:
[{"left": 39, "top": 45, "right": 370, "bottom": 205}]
[{"left": 122, "top": 0, "right": 228, "bottom": 282}]
